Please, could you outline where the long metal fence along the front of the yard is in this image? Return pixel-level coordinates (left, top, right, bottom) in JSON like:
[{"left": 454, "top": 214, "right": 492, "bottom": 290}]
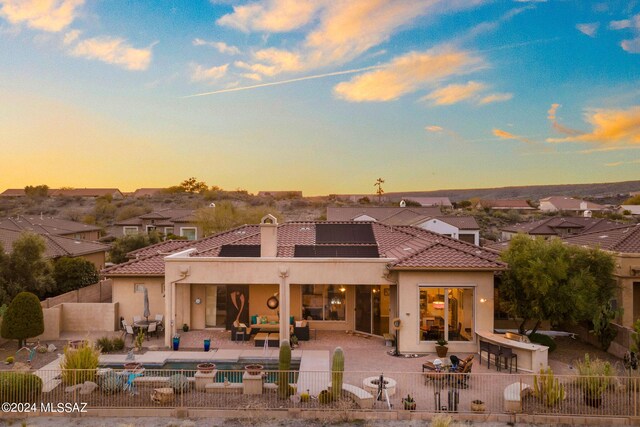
[{"left": 0, "top": 369, "right": 640, "bottom": 417}]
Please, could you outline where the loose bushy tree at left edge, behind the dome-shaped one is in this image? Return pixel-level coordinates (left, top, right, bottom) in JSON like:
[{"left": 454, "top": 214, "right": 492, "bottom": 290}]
[{"left": 0, "top": 232, "right": 55, "bottom": 303}]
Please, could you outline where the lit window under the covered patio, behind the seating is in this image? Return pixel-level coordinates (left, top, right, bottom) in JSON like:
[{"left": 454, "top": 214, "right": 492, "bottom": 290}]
[{"left": 302, "top": 285, "right": 347, "bottom": 320}]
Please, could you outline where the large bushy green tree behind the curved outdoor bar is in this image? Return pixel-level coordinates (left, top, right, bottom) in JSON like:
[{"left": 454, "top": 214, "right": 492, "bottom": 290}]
[{"left": 499, "top": 235, "right": 615, "bottom": 333}]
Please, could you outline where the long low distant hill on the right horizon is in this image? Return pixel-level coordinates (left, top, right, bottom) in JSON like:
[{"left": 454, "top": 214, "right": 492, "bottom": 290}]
[{"left": 372, "top": 181, "right": 640, "bottom": 202}]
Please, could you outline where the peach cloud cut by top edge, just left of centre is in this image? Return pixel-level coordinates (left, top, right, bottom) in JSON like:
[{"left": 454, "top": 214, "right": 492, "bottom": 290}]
[{"left": 216, "top": 0, "right": 321, "bottom": 33}]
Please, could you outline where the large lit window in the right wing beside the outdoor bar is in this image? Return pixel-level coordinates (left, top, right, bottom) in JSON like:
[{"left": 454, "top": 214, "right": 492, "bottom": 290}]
[{"left": 420, "top": 286, "right": 474, "bottom": 341}]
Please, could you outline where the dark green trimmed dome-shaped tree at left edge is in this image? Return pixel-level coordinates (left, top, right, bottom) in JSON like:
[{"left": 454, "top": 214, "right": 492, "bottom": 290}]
[{"left": 0, "top": 292, "right": 44, "bottom": 348}]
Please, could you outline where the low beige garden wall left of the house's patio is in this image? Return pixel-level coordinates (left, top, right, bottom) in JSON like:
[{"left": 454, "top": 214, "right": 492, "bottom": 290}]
[{"left": 60, "top": 303, "right": 118, "bottom": 332}]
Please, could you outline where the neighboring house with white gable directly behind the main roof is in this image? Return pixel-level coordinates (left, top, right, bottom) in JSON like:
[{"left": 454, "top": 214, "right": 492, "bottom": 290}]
[{"left": 327, "top": 207, "right": 480, "bottom": 245}]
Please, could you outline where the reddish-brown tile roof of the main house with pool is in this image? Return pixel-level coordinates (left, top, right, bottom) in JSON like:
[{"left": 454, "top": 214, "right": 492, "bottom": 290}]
[{"left": 103, "top": 221, "right": 506, "bottom": 276}]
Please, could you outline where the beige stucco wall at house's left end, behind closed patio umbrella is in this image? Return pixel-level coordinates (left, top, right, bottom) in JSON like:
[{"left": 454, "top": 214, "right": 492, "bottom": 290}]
[{"left": 112, "top": 277, "right": 165, "bottom": 325}]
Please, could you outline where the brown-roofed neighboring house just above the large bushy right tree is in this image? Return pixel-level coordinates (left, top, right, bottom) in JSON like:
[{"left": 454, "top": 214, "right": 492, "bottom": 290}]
[{"left": 500, "top": 216, "right": 620, "bottom": 241}]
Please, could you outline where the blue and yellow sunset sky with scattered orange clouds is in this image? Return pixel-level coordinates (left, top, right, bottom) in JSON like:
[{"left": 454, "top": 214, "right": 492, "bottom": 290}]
[{"left": 0, "top": 0, "right": 640, "bottom": 195}]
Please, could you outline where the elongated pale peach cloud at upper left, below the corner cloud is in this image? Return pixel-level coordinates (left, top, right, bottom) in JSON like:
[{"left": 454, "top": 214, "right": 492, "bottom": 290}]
[{"left": 70, "top": 36, "right": 152, "bottom": 71}]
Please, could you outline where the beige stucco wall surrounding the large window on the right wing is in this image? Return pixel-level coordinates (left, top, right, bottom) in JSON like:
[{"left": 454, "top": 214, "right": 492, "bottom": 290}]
[{"left": 398, "top": 271, "right": 494, "bottom": 353}]
